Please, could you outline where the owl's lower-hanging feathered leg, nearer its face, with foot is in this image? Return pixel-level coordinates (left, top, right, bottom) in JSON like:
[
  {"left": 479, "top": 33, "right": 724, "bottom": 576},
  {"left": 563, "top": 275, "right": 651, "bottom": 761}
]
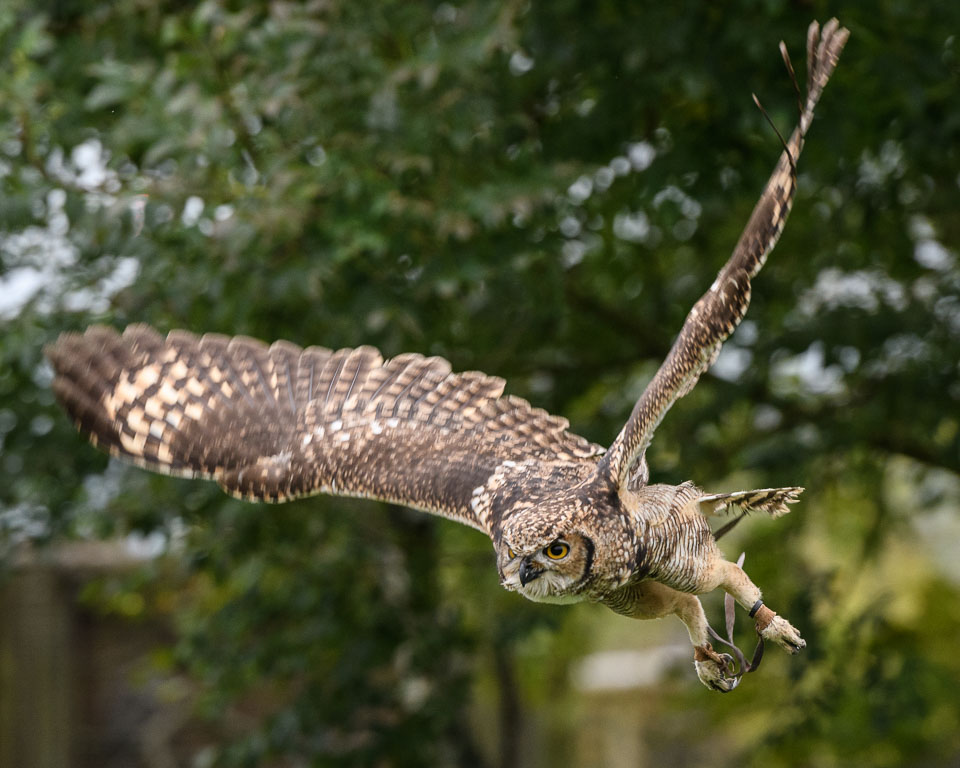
[{"left": 603, "top": 581, "right": 739, "bottom": 693}]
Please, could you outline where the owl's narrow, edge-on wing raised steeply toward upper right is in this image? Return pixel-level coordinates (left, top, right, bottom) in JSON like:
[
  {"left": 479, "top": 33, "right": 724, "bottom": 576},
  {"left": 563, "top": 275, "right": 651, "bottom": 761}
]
[{"left": 600, "top": 19, "right": 850, "bottom": 486}]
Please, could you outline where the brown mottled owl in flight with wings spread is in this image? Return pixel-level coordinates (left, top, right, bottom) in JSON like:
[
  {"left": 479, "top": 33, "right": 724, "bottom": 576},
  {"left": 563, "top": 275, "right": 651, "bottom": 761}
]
[{"left": 47, "top": 19, "right": 849, "bottom": 691}]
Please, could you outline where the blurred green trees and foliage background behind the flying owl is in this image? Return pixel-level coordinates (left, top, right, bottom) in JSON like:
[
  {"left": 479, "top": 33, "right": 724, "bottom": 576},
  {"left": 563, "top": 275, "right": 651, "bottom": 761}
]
[{"left": 0, "top": 0, "right": 960, "bottom": 768}]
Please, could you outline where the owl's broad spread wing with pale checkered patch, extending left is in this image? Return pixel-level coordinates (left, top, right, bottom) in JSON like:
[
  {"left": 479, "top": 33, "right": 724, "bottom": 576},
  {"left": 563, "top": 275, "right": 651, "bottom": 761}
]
[{"left": 46, "top": 325, "right": 603, "bottom": 532}]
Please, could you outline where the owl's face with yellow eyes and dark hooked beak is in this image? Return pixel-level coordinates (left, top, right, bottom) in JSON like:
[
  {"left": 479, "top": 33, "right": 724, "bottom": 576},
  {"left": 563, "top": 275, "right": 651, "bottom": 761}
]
[{"left": 497, "top": 532, "right": 594, "bottom": 603}]
